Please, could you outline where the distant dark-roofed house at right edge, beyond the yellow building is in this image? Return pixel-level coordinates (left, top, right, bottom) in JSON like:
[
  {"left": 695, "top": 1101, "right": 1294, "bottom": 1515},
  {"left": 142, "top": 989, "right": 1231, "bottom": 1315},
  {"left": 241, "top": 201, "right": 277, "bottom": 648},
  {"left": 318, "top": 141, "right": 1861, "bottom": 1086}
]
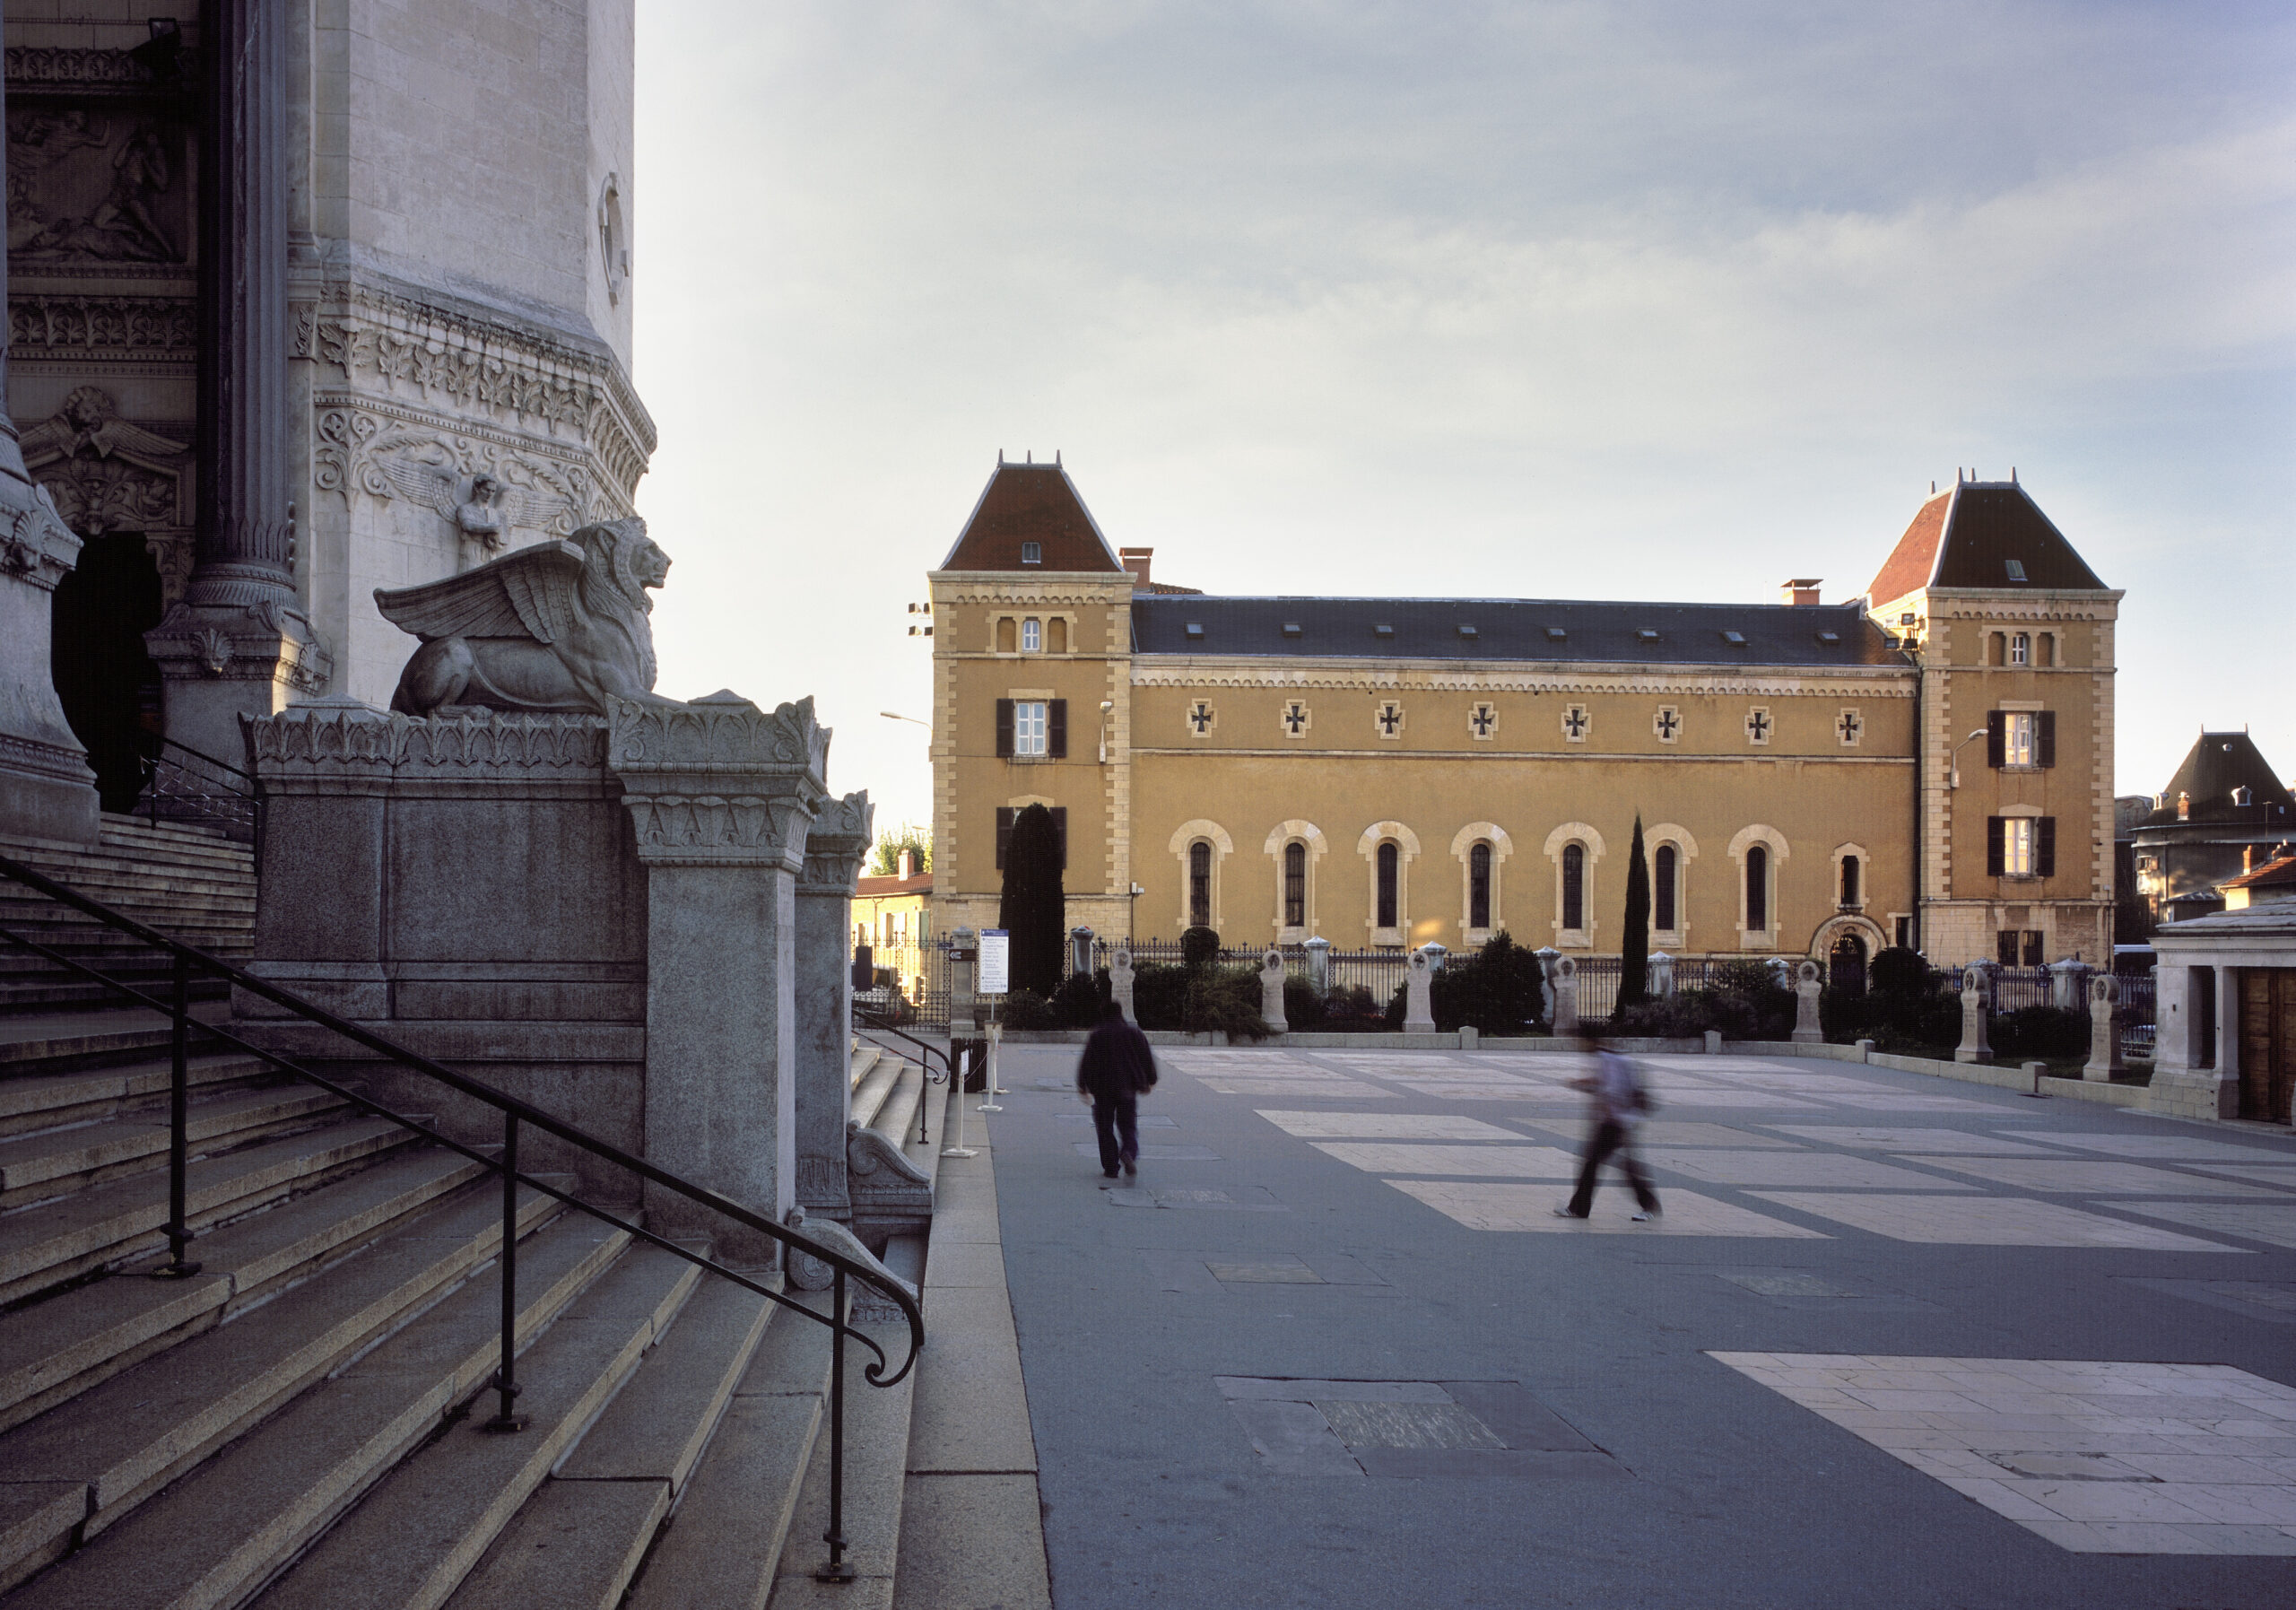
[{"left": 2128, "top": 730, "right": 2296, "bottom": 923}]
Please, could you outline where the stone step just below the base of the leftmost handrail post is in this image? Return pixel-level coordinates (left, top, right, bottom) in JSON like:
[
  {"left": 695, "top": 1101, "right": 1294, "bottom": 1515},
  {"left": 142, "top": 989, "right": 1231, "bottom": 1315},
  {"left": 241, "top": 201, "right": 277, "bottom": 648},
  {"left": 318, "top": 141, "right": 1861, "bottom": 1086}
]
[{"left": 0, "top": 1146, "right": 493, "bottom": 1431}]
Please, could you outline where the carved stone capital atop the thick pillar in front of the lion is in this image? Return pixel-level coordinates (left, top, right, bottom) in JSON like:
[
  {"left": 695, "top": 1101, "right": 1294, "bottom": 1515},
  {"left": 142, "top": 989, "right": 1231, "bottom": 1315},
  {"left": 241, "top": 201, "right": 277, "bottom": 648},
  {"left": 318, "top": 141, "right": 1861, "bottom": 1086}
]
[{"left": 606, "top": 692, "right": 829, "bottom": 873}]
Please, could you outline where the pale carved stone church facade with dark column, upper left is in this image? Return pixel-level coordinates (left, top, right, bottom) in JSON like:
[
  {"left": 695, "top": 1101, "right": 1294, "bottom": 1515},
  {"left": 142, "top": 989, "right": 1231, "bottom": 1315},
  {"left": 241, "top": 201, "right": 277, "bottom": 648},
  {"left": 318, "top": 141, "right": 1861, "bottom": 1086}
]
[{"left": 7, "top": 0, "right": 655, "bottom": 806}]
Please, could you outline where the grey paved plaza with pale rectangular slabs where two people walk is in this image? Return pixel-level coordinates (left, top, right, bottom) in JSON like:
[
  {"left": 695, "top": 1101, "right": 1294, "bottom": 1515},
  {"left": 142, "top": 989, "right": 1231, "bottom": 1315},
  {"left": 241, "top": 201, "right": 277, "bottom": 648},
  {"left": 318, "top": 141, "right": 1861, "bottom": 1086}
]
[{"left": 992, "top": 1048, "right": 2296, "bottom": 1610}]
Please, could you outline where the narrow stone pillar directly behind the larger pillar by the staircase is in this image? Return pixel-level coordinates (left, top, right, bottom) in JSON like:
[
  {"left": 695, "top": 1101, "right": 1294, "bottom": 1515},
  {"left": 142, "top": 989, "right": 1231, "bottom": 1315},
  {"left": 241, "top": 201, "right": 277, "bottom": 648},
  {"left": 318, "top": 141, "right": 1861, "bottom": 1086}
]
[{"left": 795, "top": 792, "right": 874, "bottom": 1224}]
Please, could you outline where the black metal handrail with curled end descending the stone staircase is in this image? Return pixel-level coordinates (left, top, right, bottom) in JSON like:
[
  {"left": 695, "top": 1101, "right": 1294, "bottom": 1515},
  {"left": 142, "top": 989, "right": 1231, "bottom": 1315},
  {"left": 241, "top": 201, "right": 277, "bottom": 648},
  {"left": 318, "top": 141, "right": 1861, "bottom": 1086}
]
[{"left": 0, "top": 857, "right": 926, "bottom": 1580}]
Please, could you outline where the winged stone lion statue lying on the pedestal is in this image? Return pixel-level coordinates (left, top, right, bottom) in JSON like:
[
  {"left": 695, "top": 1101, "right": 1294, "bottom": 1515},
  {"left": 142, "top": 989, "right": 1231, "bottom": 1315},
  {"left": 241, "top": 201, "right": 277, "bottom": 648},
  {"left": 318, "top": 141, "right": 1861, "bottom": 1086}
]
[{"left": 374, "top": 517, "right": 675, "bottom": 717}]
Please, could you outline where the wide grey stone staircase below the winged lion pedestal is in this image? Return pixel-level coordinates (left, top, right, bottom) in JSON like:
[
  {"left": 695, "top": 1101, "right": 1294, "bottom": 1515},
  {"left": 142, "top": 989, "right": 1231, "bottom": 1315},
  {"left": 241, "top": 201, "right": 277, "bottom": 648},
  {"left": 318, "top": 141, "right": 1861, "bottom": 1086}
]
[{"left": 0, "top": 820, "right": 930, "bottom": 1610}]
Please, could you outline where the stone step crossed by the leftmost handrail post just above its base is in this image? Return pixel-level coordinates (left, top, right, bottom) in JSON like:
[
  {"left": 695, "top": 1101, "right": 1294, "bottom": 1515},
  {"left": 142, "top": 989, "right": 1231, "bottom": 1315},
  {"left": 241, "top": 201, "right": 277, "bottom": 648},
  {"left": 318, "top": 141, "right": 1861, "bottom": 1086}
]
[{"left": 0, "top": 1118, "right": 418, "bottom": 1302}]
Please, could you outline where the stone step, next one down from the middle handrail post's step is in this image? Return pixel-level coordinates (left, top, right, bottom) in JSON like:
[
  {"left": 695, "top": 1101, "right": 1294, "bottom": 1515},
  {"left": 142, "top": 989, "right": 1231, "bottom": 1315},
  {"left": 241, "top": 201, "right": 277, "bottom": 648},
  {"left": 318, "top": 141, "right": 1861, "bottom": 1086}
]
[{"left": 448, "top": 1275, "right": 785, "bottom": 1610}]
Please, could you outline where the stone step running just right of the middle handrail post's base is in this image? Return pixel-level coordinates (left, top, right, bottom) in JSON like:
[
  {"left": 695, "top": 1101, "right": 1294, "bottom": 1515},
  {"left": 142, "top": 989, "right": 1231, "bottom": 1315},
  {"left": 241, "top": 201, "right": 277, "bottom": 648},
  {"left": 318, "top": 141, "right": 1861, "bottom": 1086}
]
[{"left": 253, "top": 1247, "right": 700, "bottom": 1610}]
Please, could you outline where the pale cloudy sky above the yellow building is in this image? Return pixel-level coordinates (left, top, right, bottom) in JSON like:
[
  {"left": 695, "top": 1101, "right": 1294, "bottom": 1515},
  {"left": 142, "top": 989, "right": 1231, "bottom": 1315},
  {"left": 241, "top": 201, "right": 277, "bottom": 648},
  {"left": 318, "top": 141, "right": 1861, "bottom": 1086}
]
[{"left": 629, "top": 0, "right": 2296, "bottom": 827}]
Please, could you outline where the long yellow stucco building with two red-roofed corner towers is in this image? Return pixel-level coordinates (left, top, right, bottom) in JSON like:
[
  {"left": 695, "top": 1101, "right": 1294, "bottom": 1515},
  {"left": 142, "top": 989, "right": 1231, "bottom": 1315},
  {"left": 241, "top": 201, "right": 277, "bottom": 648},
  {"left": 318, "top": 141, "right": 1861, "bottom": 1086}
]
[{"left": 930, "top": 462, "right": 2121, "bottom": 964}]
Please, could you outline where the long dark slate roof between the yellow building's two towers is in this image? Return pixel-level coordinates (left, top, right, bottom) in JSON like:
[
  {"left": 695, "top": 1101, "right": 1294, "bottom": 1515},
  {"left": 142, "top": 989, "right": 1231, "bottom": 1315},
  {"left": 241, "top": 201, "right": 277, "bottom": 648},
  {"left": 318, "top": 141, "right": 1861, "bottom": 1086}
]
[{"left": 1132, "top": 593, "right": 1906, "bottom": 668}]
